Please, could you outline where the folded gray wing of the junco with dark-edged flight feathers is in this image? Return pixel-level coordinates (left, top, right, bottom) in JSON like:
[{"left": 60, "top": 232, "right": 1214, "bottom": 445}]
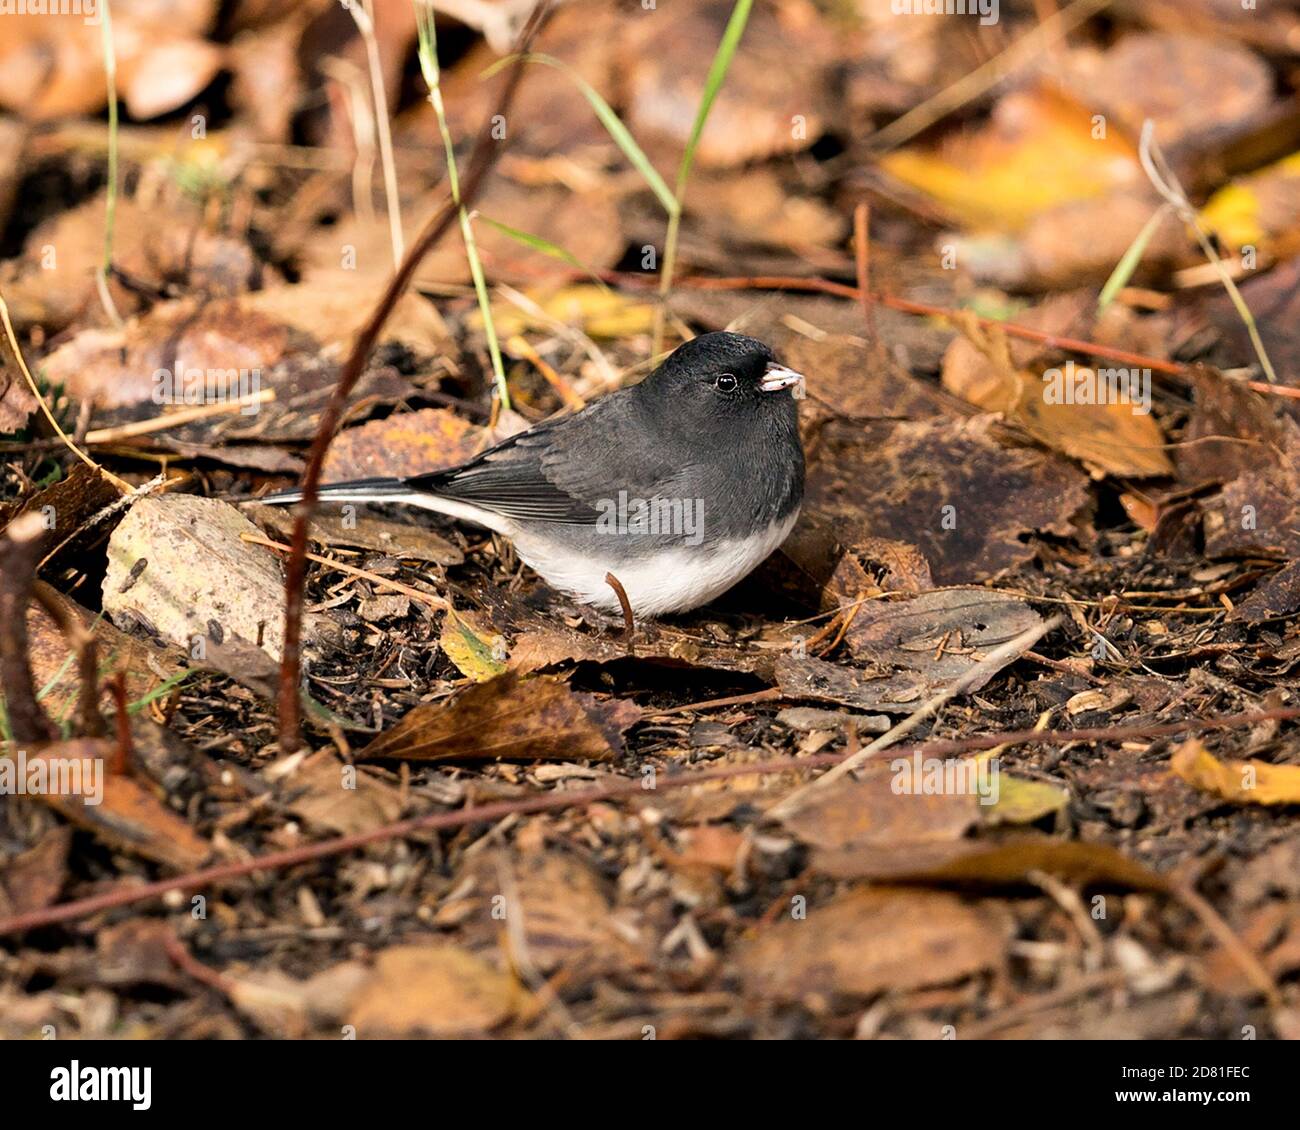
[{"left": 407, "top": 390, "right": 685, "bottom": 525}]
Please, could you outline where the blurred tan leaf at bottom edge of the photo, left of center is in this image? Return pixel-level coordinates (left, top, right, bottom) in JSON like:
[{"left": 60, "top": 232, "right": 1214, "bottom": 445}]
[{"left": 346, "top": 943, "right": 528, "bottom": 1038}]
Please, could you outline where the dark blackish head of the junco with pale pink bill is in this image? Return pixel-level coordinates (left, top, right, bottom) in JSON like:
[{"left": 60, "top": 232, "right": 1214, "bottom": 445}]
[{"left": 642, "top": 333, "right": 802, "bottom": 419}]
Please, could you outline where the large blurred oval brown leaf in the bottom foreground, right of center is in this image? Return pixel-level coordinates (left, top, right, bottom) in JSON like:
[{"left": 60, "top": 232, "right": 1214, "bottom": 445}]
[{"left": 737, "top": 889, "right": 1014, "bottom": 1001}]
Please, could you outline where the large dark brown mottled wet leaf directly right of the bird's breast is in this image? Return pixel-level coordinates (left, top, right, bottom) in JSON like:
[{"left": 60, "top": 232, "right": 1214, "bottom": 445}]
[{"left": 805, "top": 416, "right": 1089, "bottom": 584}]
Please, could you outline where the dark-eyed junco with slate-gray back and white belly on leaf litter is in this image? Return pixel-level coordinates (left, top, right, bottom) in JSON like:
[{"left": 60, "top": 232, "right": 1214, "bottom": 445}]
[{"left": 261, "top": 333, "right": 803, "bottom": 616}]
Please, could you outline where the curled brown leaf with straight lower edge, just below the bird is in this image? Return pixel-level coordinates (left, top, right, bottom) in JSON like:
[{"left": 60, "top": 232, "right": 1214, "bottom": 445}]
[{"left": 358, "top": 674, "right": 641, "bottom": 761}]
